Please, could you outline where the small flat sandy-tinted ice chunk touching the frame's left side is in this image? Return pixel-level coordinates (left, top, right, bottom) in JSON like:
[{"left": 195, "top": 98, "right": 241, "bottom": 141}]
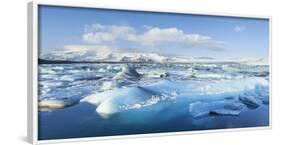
[{"left": 38, "top": 98, "right": 78, "bottom": 111}]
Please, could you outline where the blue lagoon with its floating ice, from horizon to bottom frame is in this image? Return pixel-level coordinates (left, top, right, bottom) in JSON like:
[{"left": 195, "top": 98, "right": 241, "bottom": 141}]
[{"left": 38, "top": 64, "right": 270, "bottom": 140}]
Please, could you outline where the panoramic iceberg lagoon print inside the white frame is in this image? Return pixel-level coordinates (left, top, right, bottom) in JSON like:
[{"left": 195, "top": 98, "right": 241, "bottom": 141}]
[{"left": 37, "top": 5, "right": 271, "bottom": 140}]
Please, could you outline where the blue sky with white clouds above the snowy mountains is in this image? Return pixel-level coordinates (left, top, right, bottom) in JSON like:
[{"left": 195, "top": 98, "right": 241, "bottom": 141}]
[{"left": 39, "top": 5, "right": 269, "bottom": 59}]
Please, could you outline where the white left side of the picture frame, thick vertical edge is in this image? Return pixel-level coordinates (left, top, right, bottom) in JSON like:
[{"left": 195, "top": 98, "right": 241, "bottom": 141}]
[{"left": 27, "top": 1, "right": 38, "bottom": 144}]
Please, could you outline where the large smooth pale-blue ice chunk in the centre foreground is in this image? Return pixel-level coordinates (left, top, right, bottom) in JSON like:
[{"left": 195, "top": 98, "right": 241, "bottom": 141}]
[{"left": 81, "top": 82, "right": 177, "bottom": 118}]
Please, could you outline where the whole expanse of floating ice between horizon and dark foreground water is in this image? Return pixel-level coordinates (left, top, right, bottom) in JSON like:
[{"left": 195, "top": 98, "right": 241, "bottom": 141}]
[{"left": 38, "top": 63, "right": 270, "bottom": 123}]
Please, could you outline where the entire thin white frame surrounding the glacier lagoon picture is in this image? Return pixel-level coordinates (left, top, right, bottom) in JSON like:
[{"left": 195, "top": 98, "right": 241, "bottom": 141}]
[{"left": 27, "top": 0, "right": 272, "bottom": 144}]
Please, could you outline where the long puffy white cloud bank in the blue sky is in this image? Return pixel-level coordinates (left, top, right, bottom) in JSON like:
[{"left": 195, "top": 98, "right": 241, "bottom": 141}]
[{"left": 83, "top": 24, "right": 223, "bottom": 50}]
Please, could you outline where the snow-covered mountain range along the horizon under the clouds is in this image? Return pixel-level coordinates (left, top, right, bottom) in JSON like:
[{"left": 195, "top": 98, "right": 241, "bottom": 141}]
[{"left": 39, "top": 49, "right": 268, "bottom": 65}]
